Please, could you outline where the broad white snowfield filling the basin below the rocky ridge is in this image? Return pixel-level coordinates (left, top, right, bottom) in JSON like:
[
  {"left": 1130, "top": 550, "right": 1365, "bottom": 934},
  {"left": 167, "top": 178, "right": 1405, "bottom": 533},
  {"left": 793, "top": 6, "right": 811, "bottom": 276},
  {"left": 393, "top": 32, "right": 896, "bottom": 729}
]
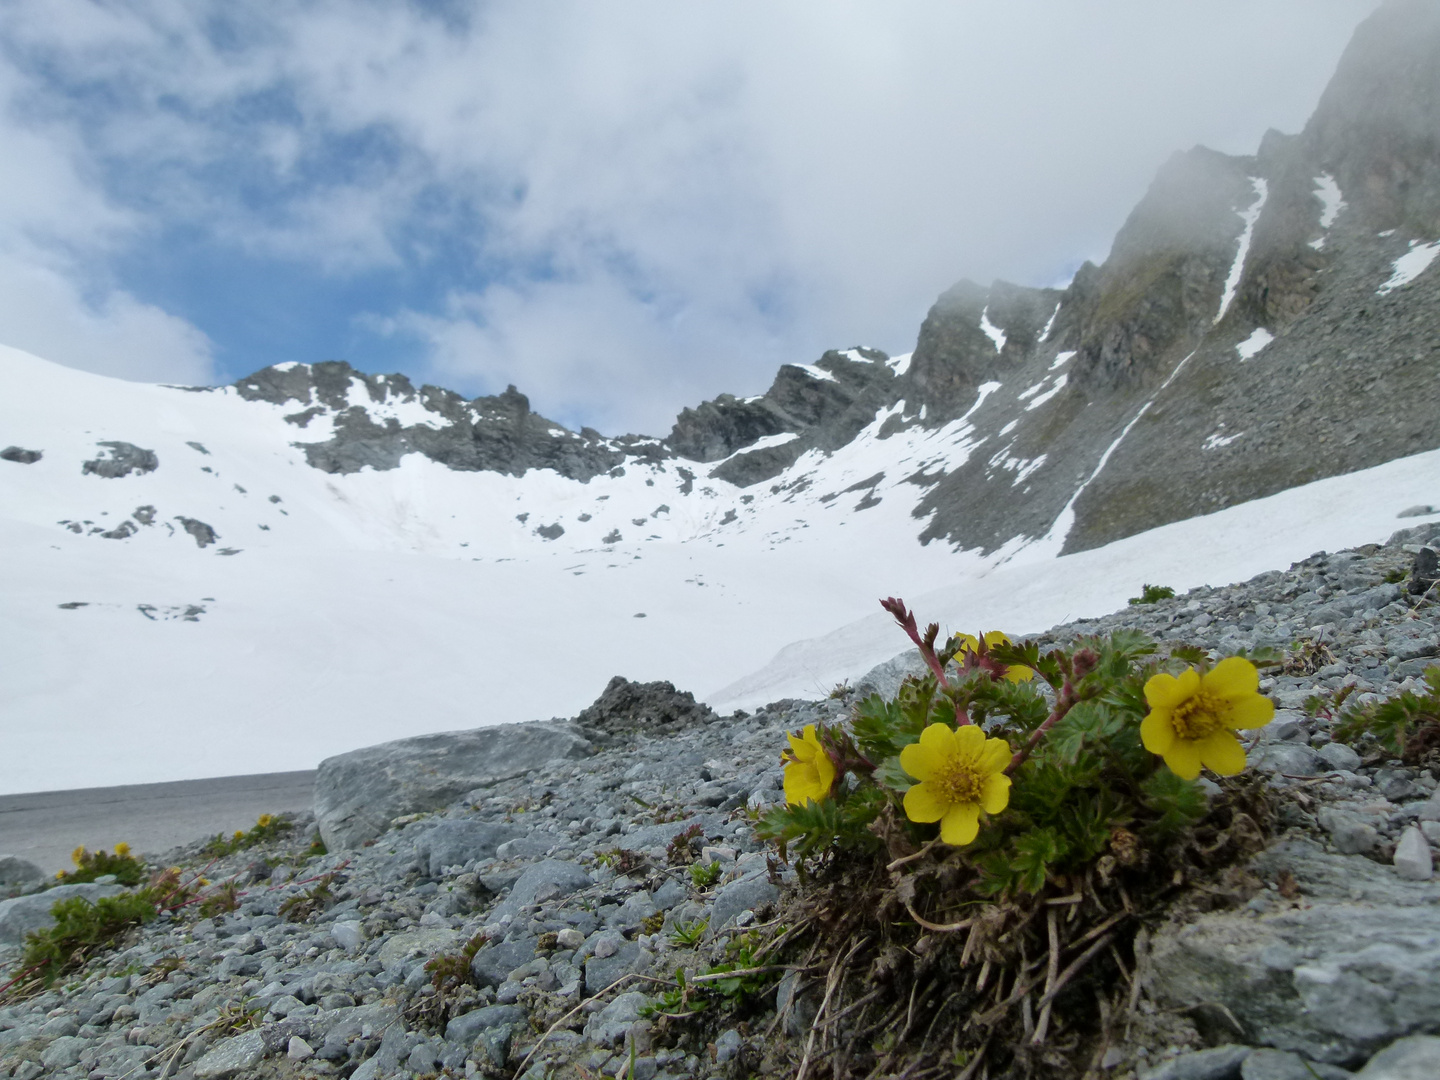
[{"left": 0, "top": 348, "right": 1440, "bottom": 792}]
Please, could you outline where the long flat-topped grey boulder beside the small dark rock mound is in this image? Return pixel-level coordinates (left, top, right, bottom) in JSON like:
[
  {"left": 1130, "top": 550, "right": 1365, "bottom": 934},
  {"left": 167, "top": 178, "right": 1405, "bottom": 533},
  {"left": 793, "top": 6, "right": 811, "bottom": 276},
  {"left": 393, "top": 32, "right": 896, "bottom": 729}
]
[{"left": 315, "top": 721, "right": 593, "bottom": 851}]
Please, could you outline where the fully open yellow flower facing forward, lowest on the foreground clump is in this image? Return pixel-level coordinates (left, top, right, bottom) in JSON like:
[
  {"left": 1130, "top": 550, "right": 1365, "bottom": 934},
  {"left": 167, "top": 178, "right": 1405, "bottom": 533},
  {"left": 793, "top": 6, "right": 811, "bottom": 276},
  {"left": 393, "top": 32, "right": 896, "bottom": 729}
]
[{"left": 900, "top": 724, "right": 1009, "bottom": 847}]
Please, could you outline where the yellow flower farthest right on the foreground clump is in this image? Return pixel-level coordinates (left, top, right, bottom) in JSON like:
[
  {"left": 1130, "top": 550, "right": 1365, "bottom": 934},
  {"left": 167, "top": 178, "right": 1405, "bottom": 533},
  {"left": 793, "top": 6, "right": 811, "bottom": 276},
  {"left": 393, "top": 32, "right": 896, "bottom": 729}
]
[{"left": 1140, "top": 657, "right": 1274, "bottom": 780}]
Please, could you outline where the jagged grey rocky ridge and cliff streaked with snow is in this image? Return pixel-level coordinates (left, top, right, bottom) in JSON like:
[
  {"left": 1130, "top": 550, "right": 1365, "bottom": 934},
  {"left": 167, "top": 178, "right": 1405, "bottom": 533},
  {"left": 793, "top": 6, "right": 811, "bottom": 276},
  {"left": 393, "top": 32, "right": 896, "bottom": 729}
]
[{"left": 224, "top": 0, "right": 1440, "bottom": 567}]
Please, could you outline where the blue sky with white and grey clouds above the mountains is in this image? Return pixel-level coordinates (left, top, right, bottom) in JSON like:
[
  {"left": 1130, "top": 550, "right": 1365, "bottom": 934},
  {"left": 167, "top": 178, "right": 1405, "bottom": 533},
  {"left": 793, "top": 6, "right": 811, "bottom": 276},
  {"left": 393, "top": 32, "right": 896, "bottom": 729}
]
[{"left": 0, "top": 0, "right": 1375, "bottom": 435}]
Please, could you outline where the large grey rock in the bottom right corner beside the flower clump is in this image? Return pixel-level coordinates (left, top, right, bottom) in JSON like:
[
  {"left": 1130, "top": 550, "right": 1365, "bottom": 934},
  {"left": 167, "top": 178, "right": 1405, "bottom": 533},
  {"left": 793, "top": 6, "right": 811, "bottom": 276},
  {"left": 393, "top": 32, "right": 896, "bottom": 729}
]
[{"left": 1146, "top": 841, "right": 1440, "bottom": 1066}]
